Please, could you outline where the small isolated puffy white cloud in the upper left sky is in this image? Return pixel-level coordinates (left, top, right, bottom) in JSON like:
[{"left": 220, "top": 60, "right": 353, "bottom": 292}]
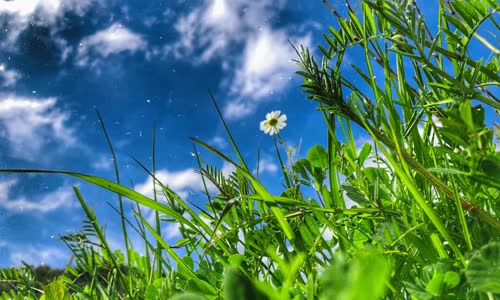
[{"left": 77, "top": 23, "right": 146, "bottom": 67}]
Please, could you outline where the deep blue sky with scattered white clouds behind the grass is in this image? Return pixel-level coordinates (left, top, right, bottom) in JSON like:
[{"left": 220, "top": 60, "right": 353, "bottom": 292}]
[{"left": 0, "top": 0, "right": 496, "bottom": 267}]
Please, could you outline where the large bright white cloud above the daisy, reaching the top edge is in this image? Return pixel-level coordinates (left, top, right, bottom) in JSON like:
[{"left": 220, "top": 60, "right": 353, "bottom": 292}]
[{"left": 164, "top": 0, "right": 311, "bottom": 120}]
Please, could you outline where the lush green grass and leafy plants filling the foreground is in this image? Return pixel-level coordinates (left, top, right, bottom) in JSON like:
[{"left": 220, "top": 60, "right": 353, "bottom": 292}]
[{"left": 0, "top": 0, "right": 500, "bottom": 299}]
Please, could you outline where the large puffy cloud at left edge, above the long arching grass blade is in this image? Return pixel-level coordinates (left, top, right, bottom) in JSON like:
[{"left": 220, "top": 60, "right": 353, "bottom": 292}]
[{"left": 0, "top": 95, "right": 76, "bottom": 161}]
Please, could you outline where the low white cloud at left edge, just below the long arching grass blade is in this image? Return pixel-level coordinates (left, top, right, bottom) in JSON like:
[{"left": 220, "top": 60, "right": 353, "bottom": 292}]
[{"left": 0, "top": 178, "right": 76, "bottom": 214}]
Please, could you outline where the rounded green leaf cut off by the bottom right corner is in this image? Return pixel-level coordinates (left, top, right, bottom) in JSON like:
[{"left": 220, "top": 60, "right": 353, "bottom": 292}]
[{"left": 465, "top": 242, "right": 500, "bottom": 294}]
